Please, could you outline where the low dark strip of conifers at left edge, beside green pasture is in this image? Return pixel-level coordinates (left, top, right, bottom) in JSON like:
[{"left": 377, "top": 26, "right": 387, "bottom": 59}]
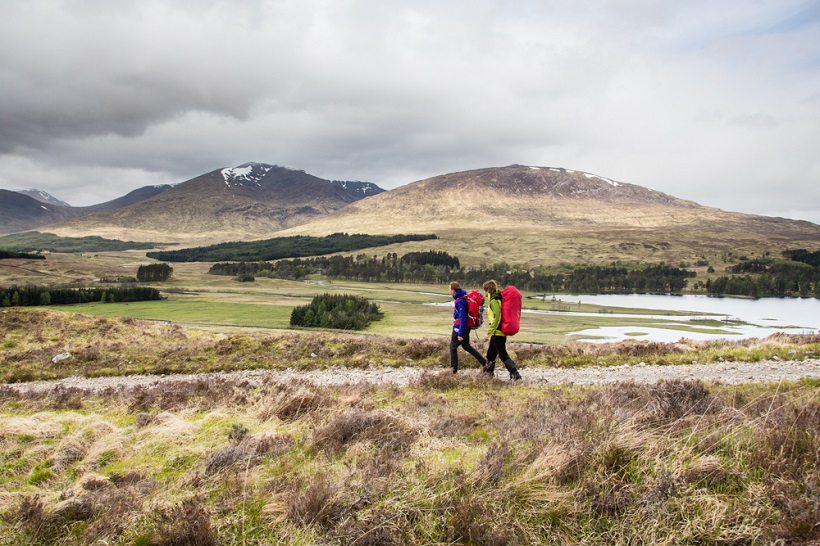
[{"left": 0, "top": 286, "right": 161, "bottom": 307}]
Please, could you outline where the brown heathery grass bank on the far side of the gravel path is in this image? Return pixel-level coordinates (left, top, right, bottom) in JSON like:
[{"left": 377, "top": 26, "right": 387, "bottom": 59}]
[{"left": 0, "top": 305, "right": 820, "bottom": 382}]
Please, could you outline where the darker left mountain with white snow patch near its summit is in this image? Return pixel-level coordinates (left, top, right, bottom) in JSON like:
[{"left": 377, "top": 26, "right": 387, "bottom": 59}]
[{"left": 50, "top": 159, "right": 383, "bottom": 242}]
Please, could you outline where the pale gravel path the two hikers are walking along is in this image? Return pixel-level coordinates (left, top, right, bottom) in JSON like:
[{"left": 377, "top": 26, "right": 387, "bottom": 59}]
[{"left": 7, "top": 359, "right": 820, "bottom": 393}]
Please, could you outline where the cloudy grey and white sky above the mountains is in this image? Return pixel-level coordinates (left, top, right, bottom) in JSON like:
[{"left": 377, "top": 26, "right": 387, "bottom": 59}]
[{"left": 0, "top": 0, "right": 820, "bottom": 224}]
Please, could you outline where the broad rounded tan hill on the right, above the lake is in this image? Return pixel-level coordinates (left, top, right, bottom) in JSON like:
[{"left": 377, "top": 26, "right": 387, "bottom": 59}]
[{"left": 280, "top": 165, "right": 820, "bottom": 264}]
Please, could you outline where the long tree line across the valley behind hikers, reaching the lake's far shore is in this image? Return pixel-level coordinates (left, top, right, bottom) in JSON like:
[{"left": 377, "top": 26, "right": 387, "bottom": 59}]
[{"left": 209, "top": 251, "right": 696, "bottom": 294}]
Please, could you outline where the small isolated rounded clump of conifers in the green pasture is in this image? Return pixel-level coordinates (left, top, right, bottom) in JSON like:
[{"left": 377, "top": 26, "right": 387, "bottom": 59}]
[{"left": 290, "top": 294, "right": 384, "bottom": 330}]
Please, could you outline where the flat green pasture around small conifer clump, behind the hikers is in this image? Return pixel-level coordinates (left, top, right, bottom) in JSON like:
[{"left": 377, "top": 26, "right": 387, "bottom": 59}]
[{"left": 44, "top": 274, "right": 748, "bottom": 343}]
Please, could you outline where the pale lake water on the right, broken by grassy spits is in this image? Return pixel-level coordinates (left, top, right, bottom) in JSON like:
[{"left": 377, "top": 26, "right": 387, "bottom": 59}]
[{"left": 545, "top": 294, "right": 820, "bottom": 342}]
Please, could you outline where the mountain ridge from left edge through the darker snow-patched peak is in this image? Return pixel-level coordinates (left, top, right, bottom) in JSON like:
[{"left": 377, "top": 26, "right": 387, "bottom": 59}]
[{"left": 0, "top": 162, "right": 384, "bottom": 238}]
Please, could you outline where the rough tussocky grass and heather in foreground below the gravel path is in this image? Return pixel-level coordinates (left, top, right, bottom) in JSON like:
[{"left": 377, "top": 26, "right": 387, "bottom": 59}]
[{"left": 0, "top": 372, "right": 820, "bottom": 545}]
